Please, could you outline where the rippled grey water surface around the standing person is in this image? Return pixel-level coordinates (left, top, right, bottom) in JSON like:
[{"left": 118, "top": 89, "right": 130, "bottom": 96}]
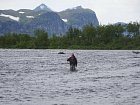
[{"left": 0, "top": 49, "right": 140, "bottom": 105}]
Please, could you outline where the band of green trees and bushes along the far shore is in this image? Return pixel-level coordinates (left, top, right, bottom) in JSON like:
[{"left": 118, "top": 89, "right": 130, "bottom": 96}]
[{"left": 0, "top": 22, "right": 140, "bottom": 49}]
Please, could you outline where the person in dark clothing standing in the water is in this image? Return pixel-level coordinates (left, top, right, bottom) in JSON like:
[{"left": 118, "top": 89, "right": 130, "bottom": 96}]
[{"left": 67, "top": 54, "right": 77, "bottom": 71}]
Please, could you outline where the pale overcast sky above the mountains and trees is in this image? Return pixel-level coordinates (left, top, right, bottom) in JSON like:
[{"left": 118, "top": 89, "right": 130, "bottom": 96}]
[{"left": 0, "top": 0, "right": 140, "bottom": 24}]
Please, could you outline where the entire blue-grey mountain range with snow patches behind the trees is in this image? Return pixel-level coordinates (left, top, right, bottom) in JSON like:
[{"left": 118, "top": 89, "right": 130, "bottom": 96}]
[{"left": 0, "top": 4, "right": 99, "bottom": 35}]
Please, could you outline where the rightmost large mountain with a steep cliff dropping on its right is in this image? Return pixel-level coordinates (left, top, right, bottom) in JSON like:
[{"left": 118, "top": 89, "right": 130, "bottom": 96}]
[{"left": 58, "top": 6, "right": 99, "bottom": 28}]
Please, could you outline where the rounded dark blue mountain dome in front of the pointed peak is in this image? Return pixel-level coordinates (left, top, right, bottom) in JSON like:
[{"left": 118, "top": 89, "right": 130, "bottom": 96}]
[{"left": 27, "top": 12, "right": 67, "bottom": 34}]
